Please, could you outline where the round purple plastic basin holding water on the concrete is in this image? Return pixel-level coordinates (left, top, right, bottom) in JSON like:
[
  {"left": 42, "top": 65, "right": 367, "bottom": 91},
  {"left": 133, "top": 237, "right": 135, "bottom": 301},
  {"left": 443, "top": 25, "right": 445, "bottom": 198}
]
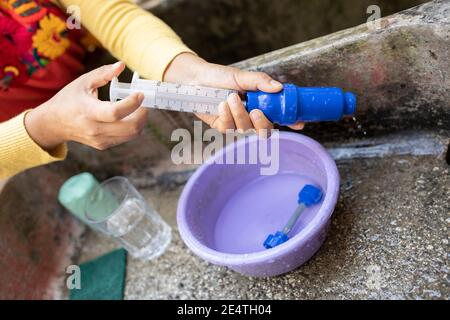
[{"left": 177, "top": 132, "right": 339, "bottom": 277}]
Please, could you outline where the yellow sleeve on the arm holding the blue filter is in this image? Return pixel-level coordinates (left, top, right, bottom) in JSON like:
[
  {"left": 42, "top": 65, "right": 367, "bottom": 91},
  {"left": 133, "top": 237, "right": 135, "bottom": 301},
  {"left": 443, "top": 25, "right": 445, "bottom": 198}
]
[{"left": 59, "top": 0, "right": 192, "bottom": 80}]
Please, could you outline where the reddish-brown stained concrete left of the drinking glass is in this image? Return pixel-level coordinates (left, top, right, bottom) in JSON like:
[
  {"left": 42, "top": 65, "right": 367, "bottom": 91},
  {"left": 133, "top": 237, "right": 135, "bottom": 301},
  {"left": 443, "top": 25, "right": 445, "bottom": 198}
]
[{"left": 0, "top": 163, "right": 84, "bottom": 300}]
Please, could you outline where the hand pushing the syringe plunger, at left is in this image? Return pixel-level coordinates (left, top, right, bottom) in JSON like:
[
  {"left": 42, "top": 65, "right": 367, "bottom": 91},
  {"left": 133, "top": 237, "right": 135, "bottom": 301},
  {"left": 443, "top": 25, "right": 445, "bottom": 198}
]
[{"left": 25, "top": 62, "right": 147, "bottom": 150}]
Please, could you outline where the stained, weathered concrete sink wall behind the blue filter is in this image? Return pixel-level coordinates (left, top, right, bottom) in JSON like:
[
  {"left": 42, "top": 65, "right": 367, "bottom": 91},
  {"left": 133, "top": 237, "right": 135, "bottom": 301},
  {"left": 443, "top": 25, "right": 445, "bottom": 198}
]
[{"left": 236, "top": 0, "right": 450, "bottom": 140}]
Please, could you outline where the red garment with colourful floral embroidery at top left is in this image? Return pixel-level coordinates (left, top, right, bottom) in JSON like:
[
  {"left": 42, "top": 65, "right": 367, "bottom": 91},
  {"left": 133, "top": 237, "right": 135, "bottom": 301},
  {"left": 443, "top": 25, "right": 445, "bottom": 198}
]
[{"left": 0, "top": 0, "right": 95, "bottom": 122}]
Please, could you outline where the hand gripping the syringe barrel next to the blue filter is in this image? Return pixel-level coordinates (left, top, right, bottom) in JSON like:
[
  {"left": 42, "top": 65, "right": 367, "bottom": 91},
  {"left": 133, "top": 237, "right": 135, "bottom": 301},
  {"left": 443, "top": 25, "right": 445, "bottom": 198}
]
[{"left": 164, "top": 53, "right": 304, "bottom": 133}]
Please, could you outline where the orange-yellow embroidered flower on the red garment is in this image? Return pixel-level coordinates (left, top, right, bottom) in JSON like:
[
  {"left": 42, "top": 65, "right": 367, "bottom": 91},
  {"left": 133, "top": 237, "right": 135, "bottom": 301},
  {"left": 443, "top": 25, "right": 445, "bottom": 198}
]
[{"left": 33, "top": 13, "right": 70, "bottom": 59}]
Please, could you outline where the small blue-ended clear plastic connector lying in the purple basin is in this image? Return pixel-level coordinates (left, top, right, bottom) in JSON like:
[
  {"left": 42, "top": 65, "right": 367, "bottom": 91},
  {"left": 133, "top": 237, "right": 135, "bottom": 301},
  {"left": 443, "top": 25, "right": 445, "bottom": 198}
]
[{"left": 263, "top": 184, "right": 323, "bottom": 249}]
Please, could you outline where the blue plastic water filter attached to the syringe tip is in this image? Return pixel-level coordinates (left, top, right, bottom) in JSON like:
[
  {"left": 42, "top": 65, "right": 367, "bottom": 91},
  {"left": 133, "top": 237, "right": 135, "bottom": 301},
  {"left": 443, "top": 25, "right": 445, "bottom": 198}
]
[{"left": 246, "top": 83, "right": 356, "bottom": 125}]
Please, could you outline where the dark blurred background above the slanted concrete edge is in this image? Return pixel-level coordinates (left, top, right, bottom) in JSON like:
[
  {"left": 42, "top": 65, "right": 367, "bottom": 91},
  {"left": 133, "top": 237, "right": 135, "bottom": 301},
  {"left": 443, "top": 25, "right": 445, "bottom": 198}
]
[{"left": 142, "top": 0, "right": 426, "bottom": 64}]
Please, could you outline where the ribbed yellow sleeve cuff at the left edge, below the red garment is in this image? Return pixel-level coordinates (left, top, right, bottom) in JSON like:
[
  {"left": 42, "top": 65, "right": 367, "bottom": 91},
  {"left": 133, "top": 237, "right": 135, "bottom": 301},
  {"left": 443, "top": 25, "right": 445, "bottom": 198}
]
[{"left": 0, "top": 110, "right": 67, "bottom": 179}]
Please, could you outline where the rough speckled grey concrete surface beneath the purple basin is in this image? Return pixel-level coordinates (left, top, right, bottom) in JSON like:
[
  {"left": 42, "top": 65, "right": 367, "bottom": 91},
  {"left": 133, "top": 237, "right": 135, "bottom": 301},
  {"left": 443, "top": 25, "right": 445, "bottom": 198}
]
[{"left": 81, "top": 151, "right": 450, "bottom": 299}]
